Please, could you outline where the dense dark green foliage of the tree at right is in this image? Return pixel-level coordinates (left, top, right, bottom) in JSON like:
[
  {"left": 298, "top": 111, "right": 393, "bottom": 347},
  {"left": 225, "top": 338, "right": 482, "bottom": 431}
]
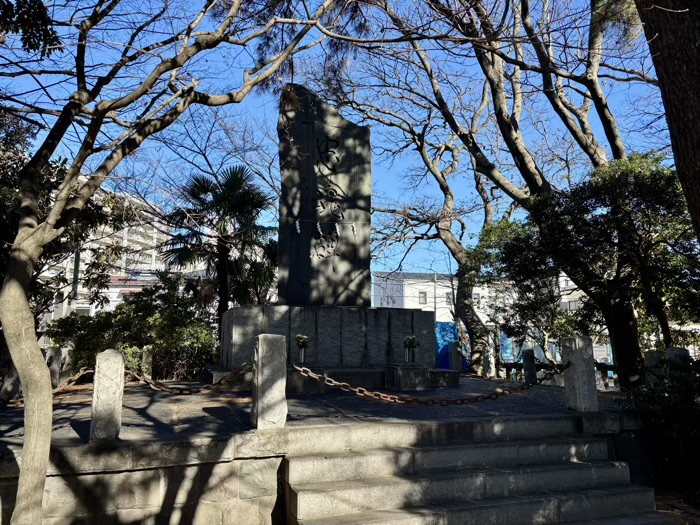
[{"left": 489, "top": 155, "right": 700, "bottom": 349}]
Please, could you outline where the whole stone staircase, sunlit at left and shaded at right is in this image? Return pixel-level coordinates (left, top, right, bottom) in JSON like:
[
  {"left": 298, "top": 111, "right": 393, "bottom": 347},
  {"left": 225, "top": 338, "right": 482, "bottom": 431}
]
[{"left": 284, "top": 416, "right": 677, "bottom": 525}]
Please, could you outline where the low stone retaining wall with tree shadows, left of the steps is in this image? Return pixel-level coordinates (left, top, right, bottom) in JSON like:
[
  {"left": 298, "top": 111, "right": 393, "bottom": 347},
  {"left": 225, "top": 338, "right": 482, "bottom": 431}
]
[{"left": 0, "top": 430, "right": 287, "bottom": 525}]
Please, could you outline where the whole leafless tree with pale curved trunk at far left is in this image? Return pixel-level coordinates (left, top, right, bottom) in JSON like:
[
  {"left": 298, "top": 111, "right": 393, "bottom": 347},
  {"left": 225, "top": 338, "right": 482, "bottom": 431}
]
[{"left": 0, "top": 0, "right": 339, "bottom": 525}]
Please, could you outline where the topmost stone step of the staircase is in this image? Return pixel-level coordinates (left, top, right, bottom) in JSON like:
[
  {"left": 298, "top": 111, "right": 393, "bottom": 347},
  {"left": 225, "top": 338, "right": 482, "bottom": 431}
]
[{"left": 287, "top": 415, "right": 580, "bottom": 456}]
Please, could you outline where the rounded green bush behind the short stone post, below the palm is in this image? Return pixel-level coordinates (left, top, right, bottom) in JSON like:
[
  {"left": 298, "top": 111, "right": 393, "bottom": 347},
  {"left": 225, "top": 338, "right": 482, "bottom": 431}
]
[{"left": 47, "top": 274, "right": 215, "bottom": 380}]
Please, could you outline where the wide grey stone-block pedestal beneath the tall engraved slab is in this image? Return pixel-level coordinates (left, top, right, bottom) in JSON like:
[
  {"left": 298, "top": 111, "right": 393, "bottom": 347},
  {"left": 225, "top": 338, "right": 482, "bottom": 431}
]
[{"left": 221, "top": 305, "right": 435, "bottom": 370}]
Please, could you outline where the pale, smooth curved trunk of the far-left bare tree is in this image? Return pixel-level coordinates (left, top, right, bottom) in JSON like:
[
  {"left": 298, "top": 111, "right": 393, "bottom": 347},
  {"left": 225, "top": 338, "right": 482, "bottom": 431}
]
[{"left": 0, "top": 243, "right": 53, "bottom": 525}]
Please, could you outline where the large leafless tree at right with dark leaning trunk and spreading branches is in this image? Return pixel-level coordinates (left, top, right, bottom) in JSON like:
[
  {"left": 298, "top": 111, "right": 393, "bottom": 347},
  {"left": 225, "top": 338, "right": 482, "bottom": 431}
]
[{"left": 310, "top": 0, "right": 657, "bottom": 386}]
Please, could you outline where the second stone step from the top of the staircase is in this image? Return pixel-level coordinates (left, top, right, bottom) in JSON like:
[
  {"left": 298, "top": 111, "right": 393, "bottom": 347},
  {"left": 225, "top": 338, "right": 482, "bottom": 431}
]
[{"left": 285, "top": 437, "right": 608, "bottom": 485}]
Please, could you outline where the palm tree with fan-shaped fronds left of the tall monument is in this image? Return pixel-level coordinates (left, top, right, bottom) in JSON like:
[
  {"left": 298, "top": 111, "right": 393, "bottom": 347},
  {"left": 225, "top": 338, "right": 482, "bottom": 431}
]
[{"left": 163, "top": 165, "right": 276, "bottom": 326}]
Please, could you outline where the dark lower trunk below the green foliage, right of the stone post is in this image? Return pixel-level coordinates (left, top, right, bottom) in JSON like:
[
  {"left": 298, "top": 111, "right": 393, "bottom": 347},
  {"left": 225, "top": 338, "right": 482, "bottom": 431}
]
[{"left": 601, "top": 300, "right": 642, "bottom": 389}]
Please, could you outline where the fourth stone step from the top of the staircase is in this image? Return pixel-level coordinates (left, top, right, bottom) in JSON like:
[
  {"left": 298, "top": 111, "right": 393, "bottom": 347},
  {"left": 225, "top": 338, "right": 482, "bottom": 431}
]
[{"left": 296, "top": 485, "right": 660, "bottom": 525}]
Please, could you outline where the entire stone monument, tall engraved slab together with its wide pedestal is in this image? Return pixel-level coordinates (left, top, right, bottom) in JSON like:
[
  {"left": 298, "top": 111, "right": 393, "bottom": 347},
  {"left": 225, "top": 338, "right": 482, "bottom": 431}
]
[{"left": 221, "top": 84, "right": 442, "bottom": 391}]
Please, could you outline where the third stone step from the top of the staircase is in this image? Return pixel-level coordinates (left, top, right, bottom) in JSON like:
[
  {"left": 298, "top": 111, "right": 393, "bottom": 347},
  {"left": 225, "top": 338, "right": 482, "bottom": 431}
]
[{"left": 289, "top": 461, "right": 628, "bottom": 520}]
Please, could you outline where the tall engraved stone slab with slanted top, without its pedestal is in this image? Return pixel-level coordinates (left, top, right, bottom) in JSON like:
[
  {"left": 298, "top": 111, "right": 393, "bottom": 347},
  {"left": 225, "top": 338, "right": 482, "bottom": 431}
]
[{"left": 277, "top": 84, "right": 372, "bottom": 307}]
